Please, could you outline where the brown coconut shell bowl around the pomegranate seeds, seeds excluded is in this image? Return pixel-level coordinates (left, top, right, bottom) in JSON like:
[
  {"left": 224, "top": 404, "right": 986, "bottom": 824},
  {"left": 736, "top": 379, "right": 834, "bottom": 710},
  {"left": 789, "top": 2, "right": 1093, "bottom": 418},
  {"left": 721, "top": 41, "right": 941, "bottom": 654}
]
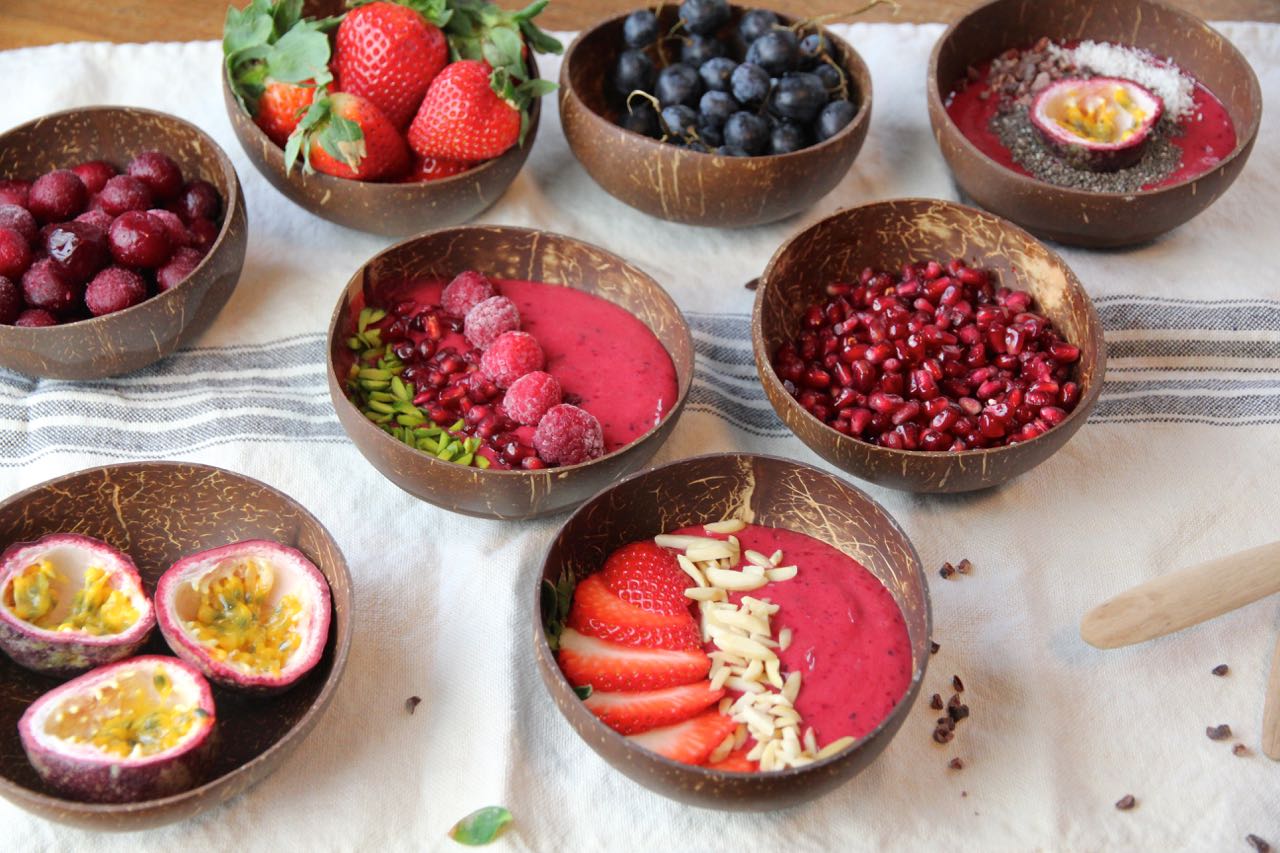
[{"left": 751, "top": 199, "right": 1106, "bottom": 492}]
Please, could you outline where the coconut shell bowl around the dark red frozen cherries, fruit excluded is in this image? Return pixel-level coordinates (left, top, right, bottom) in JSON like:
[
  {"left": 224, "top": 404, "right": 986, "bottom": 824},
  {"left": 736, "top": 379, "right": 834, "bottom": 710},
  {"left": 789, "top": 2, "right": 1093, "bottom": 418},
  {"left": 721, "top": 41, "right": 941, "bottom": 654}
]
[{"left": 0, "top": 106, "right": 248, "bottom": 379}]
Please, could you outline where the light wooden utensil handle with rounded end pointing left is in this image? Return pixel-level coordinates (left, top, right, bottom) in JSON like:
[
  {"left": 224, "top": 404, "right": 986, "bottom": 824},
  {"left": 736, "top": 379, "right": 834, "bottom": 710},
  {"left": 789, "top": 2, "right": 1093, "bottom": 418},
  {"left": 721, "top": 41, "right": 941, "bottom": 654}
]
[{"left": 1080, "top": 542, "right": 1280, "bottom": 648}]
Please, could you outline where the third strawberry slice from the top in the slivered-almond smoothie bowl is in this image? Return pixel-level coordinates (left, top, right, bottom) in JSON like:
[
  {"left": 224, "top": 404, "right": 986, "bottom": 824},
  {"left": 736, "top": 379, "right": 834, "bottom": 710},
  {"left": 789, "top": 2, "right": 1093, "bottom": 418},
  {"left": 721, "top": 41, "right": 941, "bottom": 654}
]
[{"left": 557, "top": 628, "right": 712, "bottom": 690}]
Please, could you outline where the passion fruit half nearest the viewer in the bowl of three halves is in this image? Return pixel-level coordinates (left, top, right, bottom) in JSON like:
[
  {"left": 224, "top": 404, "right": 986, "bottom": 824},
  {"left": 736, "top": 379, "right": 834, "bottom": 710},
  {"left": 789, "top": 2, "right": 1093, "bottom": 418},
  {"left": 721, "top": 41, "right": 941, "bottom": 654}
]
[{"left": 18, "top": 654, "right": 215, "bottom": 803}]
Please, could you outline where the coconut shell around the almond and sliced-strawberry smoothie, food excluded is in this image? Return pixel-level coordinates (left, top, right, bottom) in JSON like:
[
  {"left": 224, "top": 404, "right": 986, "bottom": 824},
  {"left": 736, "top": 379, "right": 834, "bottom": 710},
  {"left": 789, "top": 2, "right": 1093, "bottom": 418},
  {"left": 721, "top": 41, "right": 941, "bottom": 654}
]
[{"left": 526, "top": 453, "right": 932, "bottom": 811}]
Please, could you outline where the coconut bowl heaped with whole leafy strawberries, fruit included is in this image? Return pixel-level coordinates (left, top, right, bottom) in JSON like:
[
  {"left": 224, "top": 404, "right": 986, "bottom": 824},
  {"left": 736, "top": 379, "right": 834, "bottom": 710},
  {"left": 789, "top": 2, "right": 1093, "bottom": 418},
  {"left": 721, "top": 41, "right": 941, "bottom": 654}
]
[{"left": 223, "top": 0, "right": 561, "bottom": 236}]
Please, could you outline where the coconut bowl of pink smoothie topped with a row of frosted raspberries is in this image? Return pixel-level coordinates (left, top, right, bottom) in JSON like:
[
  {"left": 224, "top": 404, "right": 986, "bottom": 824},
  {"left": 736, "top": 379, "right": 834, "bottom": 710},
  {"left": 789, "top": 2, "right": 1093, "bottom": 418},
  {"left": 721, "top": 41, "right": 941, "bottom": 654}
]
[{"left": 329, "top": 225, "right": 694, "bottom": 519}]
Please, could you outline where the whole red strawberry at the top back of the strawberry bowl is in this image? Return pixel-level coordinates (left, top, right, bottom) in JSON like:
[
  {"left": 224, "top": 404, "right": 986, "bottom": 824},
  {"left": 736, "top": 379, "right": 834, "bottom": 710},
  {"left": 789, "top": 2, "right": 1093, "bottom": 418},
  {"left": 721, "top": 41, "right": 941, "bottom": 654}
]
[{"left": 333, "top": 0, "right": 449, "bottom": 131}]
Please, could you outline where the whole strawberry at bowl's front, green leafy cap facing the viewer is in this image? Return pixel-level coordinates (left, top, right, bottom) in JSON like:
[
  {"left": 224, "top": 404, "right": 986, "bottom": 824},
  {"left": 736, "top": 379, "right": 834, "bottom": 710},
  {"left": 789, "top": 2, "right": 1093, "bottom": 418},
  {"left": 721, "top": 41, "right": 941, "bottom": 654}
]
[{"left": 284, "top": 92, "right": 408, "bottom": 181}]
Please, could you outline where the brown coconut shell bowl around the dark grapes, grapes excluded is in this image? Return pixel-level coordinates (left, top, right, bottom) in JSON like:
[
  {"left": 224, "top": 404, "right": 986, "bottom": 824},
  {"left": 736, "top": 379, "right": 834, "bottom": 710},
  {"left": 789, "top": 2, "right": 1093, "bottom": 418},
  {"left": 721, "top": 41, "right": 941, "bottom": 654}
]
[{"left": 559, "top": 4, "right": 872, "bottom": 228}]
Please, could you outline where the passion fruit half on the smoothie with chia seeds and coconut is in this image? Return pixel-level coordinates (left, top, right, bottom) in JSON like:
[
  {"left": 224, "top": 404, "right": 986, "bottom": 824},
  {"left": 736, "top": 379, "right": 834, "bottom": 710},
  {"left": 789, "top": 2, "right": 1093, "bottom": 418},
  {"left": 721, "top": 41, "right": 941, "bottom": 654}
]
[{"left": 1030, "top": 77, "right": 1165, "bottom": 172}]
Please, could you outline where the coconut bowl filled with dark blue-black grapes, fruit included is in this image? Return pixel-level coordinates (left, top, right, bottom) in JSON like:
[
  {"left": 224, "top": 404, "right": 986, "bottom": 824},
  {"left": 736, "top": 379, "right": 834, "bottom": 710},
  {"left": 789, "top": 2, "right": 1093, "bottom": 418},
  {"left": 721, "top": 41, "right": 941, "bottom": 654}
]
[{"left": 559, "top": 0, "right": 872, "bottom": 228}]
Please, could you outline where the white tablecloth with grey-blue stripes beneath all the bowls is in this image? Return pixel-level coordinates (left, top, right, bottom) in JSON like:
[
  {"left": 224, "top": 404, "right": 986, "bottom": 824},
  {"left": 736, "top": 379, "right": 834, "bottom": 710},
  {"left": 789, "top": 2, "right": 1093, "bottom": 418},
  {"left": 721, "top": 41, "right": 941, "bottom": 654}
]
[{"left": 0, "top": 23, "right": 1280, "bottom": 853}]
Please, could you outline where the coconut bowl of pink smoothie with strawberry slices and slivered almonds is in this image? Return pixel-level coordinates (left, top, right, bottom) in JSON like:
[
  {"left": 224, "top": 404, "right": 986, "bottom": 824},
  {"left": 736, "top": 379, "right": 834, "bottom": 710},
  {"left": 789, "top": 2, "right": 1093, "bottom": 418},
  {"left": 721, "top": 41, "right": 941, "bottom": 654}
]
[{"left": 532, "top": 453, "right": 931, "bottom": 809}]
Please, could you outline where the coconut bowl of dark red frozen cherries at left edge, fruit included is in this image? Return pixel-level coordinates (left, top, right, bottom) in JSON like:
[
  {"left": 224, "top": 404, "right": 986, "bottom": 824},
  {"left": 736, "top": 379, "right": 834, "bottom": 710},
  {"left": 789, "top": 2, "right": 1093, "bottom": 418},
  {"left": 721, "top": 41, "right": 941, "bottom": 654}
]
[{"left": 0, "top": 106, "right": 247, "bottom": 379}]
